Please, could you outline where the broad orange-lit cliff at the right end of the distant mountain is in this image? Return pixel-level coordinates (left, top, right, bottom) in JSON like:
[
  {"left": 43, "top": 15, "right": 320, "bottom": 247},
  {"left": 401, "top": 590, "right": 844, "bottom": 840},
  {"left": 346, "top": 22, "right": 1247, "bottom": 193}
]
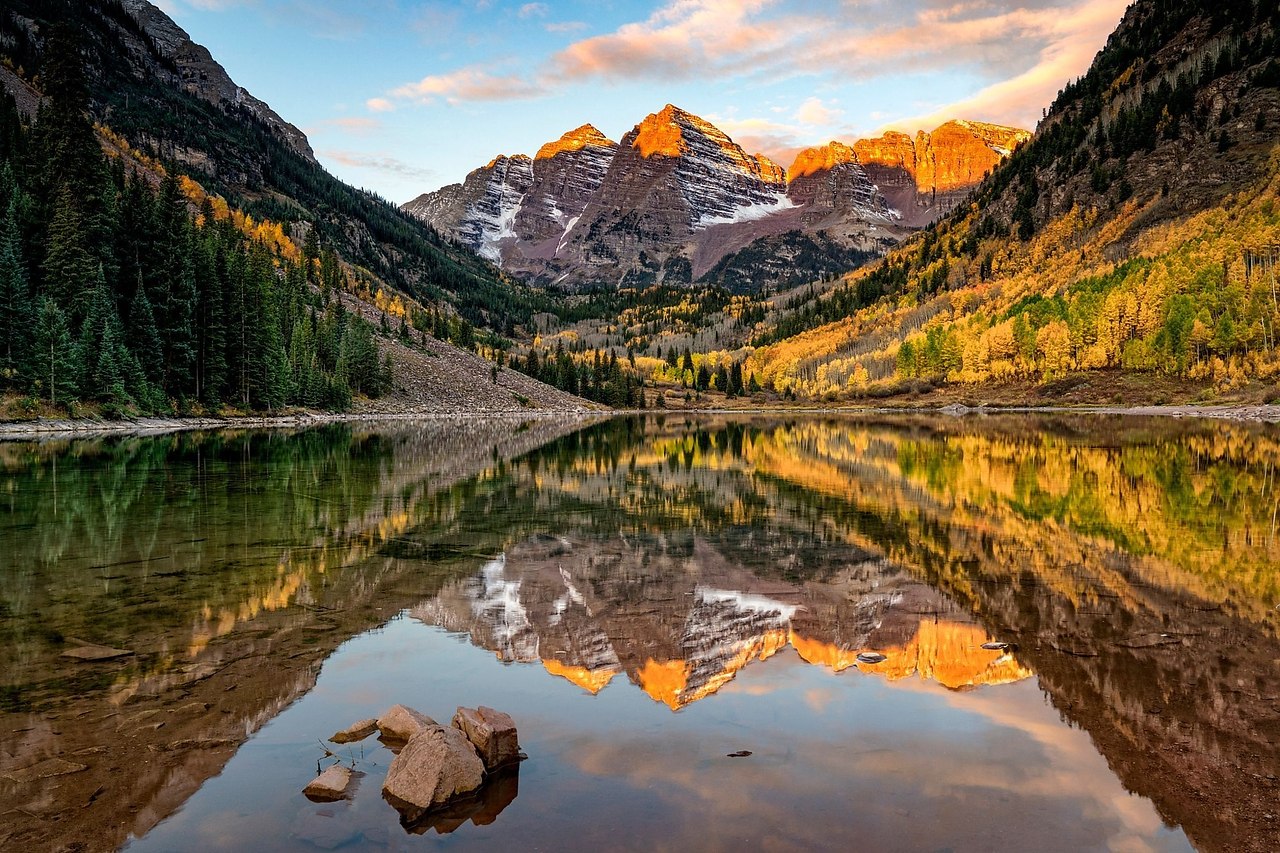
[{"left": 854, "top": 120, "right": 1030, "bottom": 225}]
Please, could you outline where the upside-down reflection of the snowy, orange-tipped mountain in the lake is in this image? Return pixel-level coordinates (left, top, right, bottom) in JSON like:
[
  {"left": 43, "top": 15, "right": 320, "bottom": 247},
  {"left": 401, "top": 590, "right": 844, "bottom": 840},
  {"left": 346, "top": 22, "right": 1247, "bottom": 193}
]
[{"left": 410, "top": 537, "right": 1032, "bottom": 711}]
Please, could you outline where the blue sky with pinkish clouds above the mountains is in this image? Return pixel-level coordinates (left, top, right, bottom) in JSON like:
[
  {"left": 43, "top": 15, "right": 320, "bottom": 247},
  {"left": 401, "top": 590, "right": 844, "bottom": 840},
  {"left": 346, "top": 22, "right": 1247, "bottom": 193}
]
[{"left": 155, "top": 0, "right": 1128, "bottom": 202}]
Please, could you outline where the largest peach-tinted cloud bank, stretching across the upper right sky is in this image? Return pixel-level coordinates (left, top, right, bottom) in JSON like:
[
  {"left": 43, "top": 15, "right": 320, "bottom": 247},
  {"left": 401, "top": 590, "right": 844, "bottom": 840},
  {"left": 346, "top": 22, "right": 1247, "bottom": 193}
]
[{"left": 370, "top": 0, "right": 1128, "bottom": 133}]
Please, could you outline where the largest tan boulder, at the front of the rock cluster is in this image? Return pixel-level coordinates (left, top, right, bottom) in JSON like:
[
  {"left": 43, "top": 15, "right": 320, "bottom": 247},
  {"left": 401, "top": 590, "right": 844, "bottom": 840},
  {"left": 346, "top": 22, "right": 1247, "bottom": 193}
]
[{"left": 383, "top": 726, "right": 484, "bottom": 821}]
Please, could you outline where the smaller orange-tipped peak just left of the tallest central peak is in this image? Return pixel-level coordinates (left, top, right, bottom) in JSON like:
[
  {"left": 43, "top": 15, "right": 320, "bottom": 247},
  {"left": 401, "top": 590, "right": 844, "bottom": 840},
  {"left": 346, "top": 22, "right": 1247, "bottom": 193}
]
[{"left": 516, "top": 124, "right": 618, "bottom": 249}]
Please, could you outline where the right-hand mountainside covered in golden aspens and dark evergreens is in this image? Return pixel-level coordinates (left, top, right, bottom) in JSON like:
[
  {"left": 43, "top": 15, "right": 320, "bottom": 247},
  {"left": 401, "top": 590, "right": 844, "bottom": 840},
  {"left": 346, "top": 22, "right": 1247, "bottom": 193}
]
[{"left": 742, "top": 0, "right": 1280, "bottom": 397}]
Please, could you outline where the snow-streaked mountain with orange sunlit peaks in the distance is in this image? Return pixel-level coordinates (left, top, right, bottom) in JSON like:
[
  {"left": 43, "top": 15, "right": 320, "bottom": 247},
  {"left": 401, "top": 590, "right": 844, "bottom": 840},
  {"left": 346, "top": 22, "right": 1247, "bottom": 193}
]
[{"left": 404, "top": 104, "right": 1028, "bottom": 288}]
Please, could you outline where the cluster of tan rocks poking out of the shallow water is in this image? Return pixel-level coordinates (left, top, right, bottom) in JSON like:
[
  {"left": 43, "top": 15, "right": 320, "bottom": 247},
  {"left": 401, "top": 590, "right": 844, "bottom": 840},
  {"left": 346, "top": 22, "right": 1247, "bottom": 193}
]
[{"left": 302, "top": 704, "right": 525, "bottom": 822}]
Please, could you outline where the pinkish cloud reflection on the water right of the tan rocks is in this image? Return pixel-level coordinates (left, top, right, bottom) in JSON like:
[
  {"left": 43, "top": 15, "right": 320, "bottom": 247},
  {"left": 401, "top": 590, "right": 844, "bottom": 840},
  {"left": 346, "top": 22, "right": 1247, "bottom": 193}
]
[{"left": 545, "top": 675, "right": 1184, "bottom": 850}]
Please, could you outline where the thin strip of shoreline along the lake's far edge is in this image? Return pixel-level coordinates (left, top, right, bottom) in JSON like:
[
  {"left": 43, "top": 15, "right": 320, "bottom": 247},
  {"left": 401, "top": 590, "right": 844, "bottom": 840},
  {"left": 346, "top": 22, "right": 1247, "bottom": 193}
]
[{"left": 0, "top": 403, "right": 1280, "bottom": 441}]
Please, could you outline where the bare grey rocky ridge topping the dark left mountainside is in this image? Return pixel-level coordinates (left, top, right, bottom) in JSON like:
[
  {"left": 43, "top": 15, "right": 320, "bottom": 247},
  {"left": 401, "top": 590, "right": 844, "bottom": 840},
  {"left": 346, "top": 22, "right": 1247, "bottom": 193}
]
[{"left": 120, "top": 0, "right": 315, "bottom": 163}]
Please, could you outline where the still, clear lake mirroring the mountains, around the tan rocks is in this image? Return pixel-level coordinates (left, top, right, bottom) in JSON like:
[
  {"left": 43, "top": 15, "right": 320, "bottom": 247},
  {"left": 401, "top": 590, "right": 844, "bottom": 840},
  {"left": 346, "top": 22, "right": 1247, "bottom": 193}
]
[{"left": 0, "top": 414, "right": 1280, "bottom": 852}]
